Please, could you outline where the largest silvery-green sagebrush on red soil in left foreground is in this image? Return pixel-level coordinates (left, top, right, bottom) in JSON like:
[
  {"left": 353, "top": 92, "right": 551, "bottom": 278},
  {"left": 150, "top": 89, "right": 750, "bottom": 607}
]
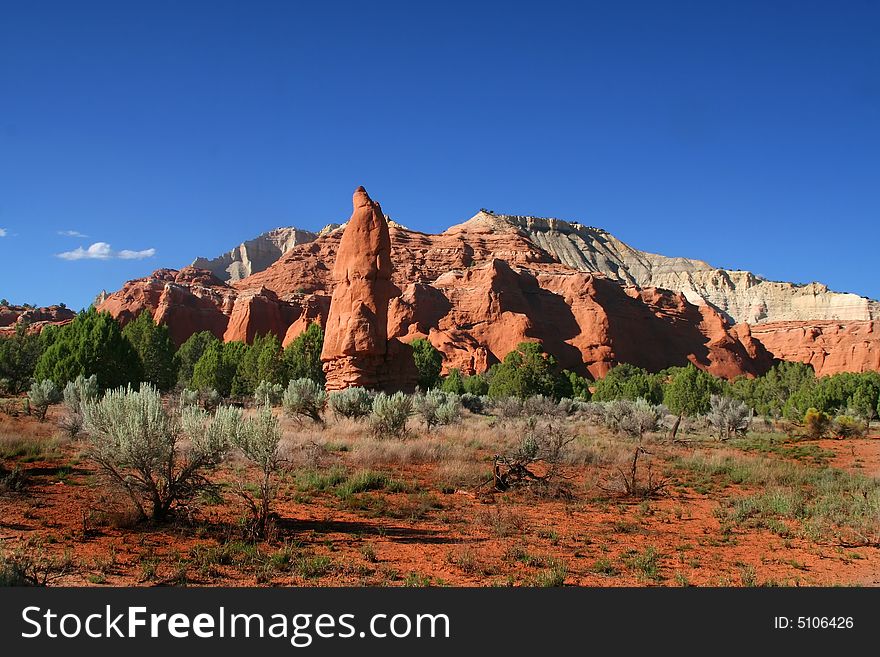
[{"left": 82, "top": 384, "right": 234, "bottom": 521}]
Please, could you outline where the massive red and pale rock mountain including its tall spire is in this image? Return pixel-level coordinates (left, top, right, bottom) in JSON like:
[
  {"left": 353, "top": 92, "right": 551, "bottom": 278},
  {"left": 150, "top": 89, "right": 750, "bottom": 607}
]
[{"left": 101, "top": 191, "right": 880, "bottom": 380}]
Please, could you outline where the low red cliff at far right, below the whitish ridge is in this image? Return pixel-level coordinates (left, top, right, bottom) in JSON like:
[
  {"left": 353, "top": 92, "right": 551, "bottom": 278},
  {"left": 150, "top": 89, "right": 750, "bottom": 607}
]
[{"left": 751, "top": 320, "right": 880, "bottom": 376}]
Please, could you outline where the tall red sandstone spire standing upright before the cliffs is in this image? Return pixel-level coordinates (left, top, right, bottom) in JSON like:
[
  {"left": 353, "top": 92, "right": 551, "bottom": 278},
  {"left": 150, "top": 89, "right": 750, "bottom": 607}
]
[{"left": 321, "top": 187, "right": 417, "bottom": 390}]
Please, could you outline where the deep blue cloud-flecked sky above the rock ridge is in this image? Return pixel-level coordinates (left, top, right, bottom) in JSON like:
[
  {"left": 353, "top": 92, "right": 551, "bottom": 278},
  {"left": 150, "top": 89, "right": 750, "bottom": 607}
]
[{"left": 0, "top": 0, "right": 880, "bottom": 307}]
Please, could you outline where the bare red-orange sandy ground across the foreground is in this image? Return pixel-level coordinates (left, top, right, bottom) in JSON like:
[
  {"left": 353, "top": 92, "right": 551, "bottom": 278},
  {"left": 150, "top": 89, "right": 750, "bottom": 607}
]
[{"left": 0, "top": 408, "right": 880, "bottom": 586}]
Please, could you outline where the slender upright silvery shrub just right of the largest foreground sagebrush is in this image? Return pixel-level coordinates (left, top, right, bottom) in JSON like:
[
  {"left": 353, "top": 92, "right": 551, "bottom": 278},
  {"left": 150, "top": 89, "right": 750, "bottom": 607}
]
[{"left": 232, "top": 402, "right": 284, "bottom": 538}]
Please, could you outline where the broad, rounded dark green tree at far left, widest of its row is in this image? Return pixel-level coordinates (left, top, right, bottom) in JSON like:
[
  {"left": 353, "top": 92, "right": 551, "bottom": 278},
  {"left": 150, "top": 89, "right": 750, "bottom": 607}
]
[{"left": 34, "top": 308, "right": 143, "bottom": 389}]
